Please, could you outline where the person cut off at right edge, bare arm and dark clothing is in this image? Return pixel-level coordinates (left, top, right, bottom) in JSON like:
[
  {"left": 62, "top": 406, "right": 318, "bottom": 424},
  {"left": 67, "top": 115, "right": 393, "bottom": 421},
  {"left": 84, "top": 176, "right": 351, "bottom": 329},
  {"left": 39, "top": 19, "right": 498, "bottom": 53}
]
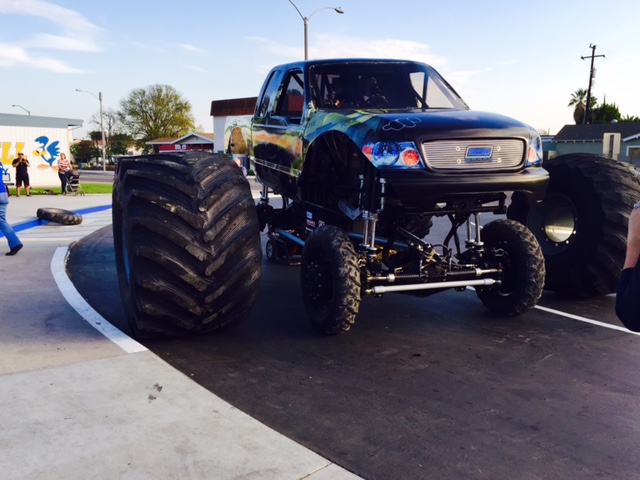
[{"left": 616, "top": 202, "right": 640, "bottom": 332}]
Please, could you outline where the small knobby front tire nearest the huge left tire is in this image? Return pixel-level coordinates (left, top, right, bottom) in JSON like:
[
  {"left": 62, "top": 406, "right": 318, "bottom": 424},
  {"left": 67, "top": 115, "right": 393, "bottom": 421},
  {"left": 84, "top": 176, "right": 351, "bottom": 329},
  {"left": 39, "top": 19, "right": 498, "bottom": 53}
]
[{"left": 300, "top": 225, "right": 361, "bottom": 335}]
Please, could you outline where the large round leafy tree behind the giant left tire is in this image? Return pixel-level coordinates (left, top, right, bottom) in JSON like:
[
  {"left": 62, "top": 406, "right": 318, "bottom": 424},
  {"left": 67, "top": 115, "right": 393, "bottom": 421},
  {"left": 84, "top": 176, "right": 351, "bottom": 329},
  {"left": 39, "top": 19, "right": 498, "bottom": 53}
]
[{"left": 120, "top": 84, "right": 195, "bottom": 152}]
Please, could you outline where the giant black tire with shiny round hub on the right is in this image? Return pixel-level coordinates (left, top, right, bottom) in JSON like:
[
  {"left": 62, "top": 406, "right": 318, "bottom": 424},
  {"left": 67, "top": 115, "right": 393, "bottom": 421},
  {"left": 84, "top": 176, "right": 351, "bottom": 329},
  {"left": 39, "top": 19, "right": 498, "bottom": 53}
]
[{"left": 507, "top": 154, "right": 640, "bottom": 298}]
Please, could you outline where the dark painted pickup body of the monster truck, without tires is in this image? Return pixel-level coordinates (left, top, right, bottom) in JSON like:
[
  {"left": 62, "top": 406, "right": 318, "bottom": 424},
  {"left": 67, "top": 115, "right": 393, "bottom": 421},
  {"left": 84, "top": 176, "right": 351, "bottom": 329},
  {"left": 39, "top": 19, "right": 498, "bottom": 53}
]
[{"left": 250, "top": 59, "right": 548, "bottom": 219}]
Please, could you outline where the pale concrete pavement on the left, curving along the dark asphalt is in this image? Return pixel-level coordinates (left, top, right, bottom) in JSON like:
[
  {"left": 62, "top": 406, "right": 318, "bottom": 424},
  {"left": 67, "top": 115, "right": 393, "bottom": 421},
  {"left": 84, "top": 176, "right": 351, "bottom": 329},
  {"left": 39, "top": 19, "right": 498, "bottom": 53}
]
[{"left": 0, "top": 195, "right": 358, "bottom": 480}]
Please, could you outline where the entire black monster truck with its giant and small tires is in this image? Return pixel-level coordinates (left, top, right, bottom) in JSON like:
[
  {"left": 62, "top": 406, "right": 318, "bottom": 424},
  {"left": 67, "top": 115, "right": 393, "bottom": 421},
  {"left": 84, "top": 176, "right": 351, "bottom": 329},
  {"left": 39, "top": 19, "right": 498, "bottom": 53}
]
[{"left": 113, "top": 59, "right": 640, "bottom": 336}]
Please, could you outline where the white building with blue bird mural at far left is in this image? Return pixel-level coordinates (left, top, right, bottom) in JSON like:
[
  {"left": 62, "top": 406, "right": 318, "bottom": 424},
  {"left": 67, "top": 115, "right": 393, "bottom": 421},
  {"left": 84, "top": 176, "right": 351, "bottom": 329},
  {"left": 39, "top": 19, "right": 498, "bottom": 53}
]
[{"left": 0, "top": 113, "right": 82, "bottom": 187}]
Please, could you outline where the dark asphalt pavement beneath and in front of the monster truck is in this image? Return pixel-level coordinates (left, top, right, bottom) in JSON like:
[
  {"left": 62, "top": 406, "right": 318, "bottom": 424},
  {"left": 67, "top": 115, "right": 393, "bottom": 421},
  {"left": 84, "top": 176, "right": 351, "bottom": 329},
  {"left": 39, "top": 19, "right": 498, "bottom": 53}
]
[{"left": 68, "top": 215, "right": 640, "bottom": 479}]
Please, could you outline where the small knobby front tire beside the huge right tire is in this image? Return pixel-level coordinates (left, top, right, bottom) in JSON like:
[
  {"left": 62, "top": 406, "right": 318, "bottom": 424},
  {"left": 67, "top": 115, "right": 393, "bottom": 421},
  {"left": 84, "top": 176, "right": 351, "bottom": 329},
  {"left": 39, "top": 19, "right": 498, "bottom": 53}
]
[{"left": 476, "top": 220, "right": 545, "bottom": 316}]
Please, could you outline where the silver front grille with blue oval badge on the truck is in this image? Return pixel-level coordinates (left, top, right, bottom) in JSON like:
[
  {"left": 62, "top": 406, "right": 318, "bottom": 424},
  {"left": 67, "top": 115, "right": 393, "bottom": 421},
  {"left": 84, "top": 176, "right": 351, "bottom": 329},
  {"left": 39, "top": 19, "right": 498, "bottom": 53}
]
[{"left": 422, "top": 139, "right": 525, "bottom": 171}]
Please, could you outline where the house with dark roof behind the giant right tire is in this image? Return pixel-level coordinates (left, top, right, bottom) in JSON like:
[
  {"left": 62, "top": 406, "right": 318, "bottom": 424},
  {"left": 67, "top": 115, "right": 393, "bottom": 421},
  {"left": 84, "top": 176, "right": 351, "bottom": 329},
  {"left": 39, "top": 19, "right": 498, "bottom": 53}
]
[{"left": 549, "top": 122, "right": 640, "bottom": 166}]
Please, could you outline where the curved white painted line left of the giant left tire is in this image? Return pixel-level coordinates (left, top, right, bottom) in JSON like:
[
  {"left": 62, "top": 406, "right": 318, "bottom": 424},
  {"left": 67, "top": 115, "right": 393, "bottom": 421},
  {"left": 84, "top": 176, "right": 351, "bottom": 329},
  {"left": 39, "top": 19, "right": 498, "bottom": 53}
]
[{"left": 51, "top": 247, "right": 147, "bottom": 353}]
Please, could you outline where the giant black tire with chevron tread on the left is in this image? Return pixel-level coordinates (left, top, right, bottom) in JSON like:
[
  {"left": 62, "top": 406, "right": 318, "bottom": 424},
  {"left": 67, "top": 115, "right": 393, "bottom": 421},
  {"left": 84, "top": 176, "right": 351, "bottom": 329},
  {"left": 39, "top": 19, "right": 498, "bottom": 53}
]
[{"left": 113, "top": 152, "right": 262, "bottom": 337}]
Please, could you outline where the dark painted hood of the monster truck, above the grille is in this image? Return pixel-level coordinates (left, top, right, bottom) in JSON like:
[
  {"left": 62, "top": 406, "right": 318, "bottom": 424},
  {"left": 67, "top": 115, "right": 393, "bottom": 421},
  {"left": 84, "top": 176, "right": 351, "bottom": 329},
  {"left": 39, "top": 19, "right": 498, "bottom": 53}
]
[{"left": 305, "top": 109, "right": 535, "bottom": 147}]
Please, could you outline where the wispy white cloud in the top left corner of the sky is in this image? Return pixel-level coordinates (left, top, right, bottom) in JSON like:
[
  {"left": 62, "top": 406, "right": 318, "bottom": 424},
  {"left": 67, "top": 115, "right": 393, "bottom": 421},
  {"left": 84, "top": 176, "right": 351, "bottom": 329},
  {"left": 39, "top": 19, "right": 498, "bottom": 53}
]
[{"left": 0, "top": 0, "right": 102, "bottom": 73}]
